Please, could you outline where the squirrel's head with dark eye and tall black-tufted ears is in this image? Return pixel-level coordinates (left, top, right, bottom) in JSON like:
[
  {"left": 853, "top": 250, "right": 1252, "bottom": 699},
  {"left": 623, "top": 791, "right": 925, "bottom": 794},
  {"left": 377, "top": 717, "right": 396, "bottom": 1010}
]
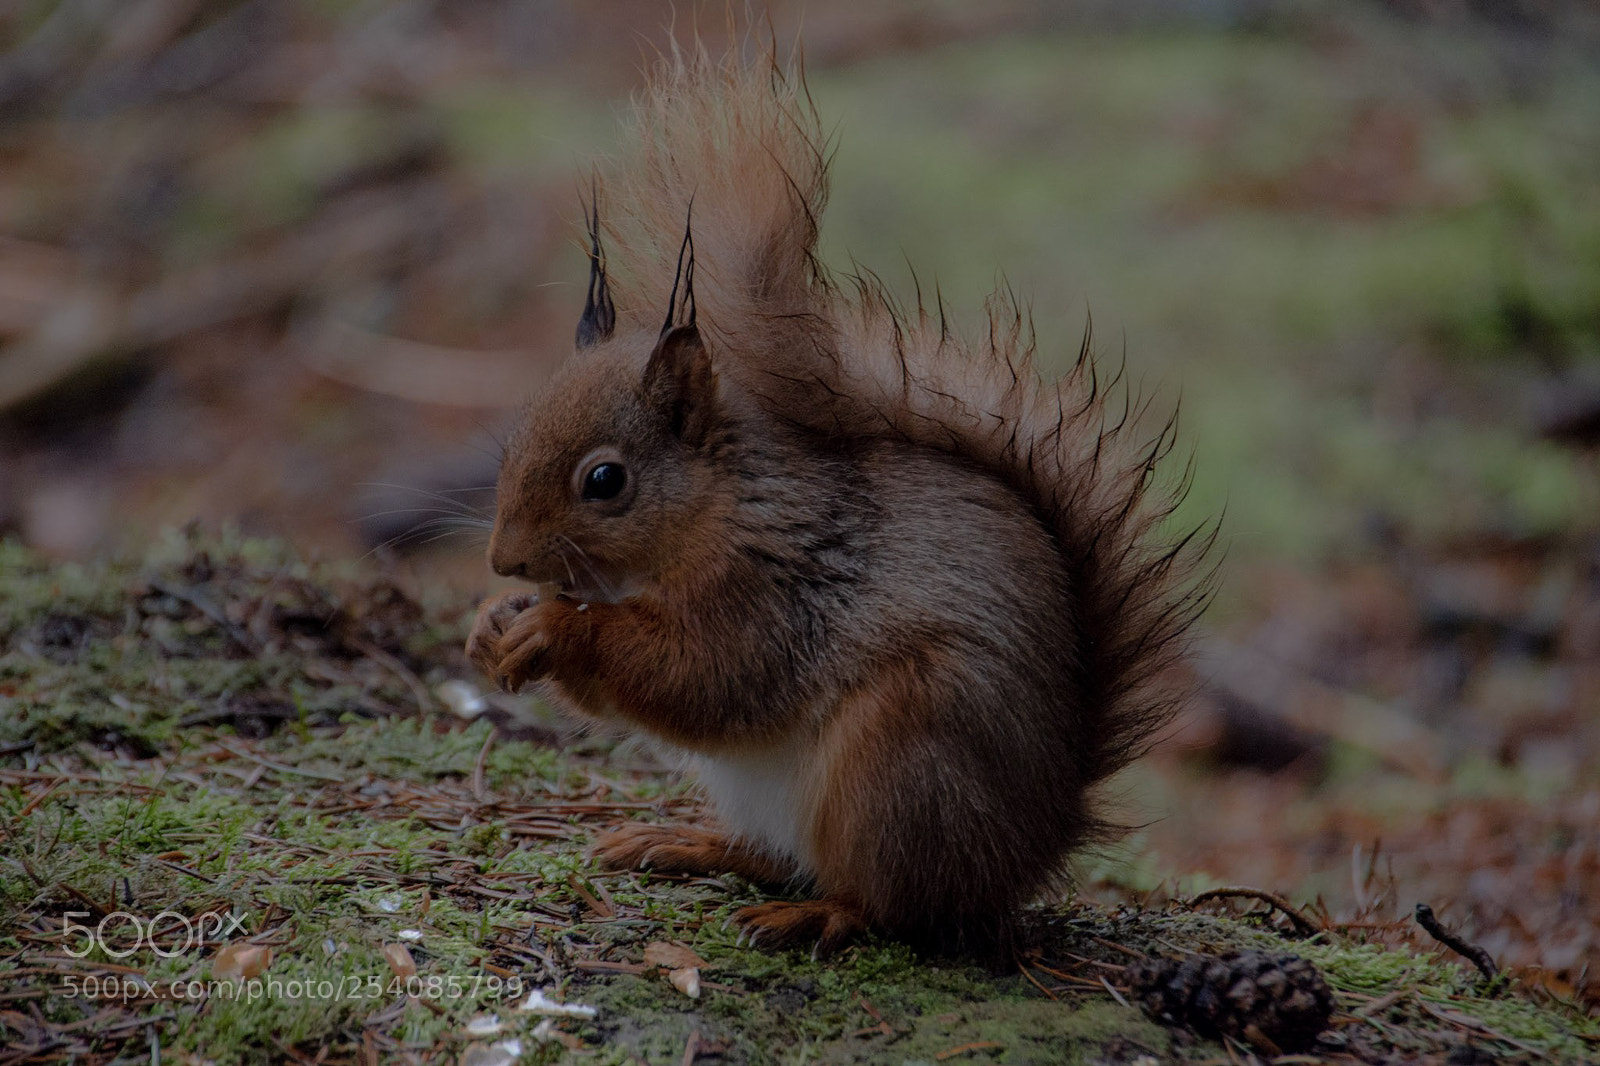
[{"left": 490, "top": 204, "right": 718, "bottom": 600}]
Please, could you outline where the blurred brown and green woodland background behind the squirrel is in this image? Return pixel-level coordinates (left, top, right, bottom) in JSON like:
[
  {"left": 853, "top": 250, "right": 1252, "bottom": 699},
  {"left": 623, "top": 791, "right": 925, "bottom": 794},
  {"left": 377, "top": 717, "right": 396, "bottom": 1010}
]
[{"left": 0, "top": 0, "right": 1600, "bottom": 1008}]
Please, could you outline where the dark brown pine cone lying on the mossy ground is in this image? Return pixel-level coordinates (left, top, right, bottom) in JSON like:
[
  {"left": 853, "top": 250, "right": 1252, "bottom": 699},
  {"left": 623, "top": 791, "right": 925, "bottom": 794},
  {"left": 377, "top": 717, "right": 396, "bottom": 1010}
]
[{"left": 1128, "top": 951, "right": 1333, "bottom": 1052}]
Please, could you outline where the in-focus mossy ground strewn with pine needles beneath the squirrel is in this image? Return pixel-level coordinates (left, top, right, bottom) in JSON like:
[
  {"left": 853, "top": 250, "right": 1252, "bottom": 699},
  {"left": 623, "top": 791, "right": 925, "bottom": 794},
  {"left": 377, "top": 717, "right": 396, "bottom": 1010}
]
[{"left": 0, "top": 535, "right": 1600, "bottom": 1066}]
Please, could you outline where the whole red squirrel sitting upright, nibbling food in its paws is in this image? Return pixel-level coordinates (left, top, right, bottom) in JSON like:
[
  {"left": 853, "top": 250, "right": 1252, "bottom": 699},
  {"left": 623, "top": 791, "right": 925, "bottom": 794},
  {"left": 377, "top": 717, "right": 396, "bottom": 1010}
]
[{"left": 467, "top": 50, "right": 1206, "bottom": 951}]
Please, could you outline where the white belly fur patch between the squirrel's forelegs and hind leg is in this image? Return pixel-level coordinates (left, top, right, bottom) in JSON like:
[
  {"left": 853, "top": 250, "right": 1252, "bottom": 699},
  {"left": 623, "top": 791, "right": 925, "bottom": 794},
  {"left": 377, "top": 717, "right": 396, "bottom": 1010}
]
[{"left": 685, "top": 729, "right": 818, "bottom": 874}]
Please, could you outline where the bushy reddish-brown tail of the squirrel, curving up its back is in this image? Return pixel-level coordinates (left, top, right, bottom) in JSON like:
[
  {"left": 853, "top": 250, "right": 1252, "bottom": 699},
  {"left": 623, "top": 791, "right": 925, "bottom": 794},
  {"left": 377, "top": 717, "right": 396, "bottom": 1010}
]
[{"left": 605, "top": 50, "right": 1214, "bottom": 832}]
